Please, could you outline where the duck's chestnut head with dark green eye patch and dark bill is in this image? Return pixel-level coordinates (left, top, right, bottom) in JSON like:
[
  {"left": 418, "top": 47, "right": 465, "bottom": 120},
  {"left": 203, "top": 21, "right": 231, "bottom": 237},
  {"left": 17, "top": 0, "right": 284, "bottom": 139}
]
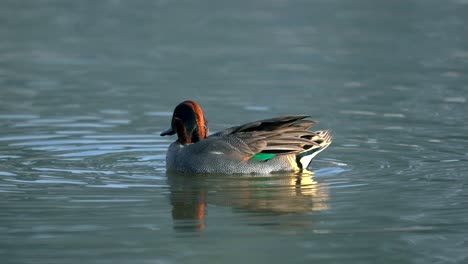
[{"left": 161, "top": 101, "right": 208, "bottom": 144}]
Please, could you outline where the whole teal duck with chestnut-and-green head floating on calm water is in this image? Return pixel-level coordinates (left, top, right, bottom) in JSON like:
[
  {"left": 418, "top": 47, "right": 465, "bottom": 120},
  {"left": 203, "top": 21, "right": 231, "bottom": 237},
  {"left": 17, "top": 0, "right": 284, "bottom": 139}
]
[{"left": 160, "top": 100, "right": 332, "bottom": 174}]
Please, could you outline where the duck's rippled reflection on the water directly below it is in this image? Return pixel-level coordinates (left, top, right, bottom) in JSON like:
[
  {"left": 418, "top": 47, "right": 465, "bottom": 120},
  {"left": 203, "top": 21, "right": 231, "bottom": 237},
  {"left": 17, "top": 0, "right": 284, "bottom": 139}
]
[{"left": 167, "top": 174, "right": 328, "bottom": 230}]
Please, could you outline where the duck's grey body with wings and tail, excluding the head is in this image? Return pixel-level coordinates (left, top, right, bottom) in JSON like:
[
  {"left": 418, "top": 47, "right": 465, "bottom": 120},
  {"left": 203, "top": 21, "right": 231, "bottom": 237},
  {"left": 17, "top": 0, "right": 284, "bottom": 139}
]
[{"left": 167, "top": 115, "right": 331, "bottom": 173}]
